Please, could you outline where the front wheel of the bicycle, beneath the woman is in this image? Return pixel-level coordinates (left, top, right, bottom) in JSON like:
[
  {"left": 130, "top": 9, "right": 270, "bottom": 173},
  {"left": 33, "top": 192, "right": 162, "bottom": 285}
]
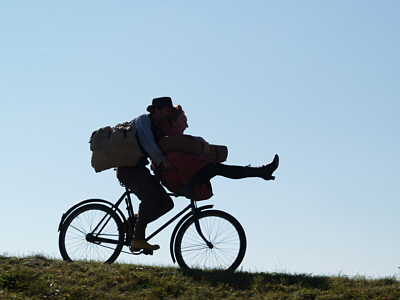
[{"left": 175, "top": 210, "right": 247, "bottom": 271}]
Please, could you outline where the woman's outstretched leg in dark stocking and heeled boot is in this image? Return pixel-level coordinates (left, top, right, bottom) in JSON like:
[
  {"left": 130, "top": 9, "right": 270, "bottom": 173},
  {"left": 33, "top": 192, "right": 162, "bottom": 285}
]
[{"left": 175, "top": 155, "right": 279, "bottom": 199}]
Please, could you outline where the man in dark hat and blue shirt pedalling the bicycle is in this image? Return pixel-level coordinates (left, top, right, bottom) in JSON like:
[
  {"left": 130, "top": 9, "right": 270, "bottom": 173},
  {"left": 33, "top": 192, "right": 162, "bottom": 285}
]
[{"left": 117, "top": 97, "right": 174, "bottom": 251}]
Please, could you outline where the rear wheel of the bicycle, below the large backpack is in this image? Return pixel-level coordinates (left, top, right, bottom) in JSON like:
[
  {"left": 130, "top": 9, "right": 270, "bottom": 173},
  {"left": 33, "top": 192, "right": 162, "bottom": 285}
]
[{"left": 59, "top": 204, "right": 125, "bottom": 263}]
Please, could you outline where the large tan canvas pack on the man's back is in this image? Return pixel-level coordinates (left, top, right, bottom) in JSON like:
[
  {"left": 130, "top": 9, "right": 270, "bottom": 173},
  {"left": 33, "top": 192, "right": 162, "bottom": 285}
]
[{"left": 90, "top": 123, "right": 143, "bottom": 172}]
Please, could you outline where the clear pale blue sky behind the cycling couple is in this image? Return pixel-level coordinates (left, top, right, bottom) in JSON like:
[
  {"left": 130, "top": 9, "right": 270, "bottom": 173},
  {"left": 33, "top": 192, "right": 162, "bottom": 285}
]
[{"left": 0, "top": 0, "right": 400, "bottom": 277}]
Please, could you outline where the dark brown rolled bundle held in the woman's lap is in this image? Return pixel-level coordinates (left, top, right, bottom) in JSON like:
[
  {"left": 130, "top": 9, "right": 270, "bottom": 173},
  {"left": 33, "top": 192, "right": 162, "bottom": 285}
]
[{"left": 158, "top": 135, "right": 228, "bottom": 163}]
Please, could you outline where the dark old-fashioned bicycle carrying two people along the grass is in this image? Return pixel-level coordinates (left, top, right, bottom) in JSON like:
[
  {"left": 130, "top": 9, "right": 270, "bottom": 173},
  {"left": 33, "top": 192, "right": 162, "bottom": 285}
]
[{"left": 58, "top": 187, "right": 247, "bottom": 271}]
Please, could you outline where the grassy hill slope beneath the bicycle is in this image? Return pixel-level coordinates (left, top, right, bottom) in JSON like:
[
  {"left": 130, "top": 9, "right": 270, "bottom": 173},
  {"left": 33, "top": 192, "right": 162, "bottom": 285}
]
[{"left": 0, "top": 255, "right": 400, "bottom": 300}]
